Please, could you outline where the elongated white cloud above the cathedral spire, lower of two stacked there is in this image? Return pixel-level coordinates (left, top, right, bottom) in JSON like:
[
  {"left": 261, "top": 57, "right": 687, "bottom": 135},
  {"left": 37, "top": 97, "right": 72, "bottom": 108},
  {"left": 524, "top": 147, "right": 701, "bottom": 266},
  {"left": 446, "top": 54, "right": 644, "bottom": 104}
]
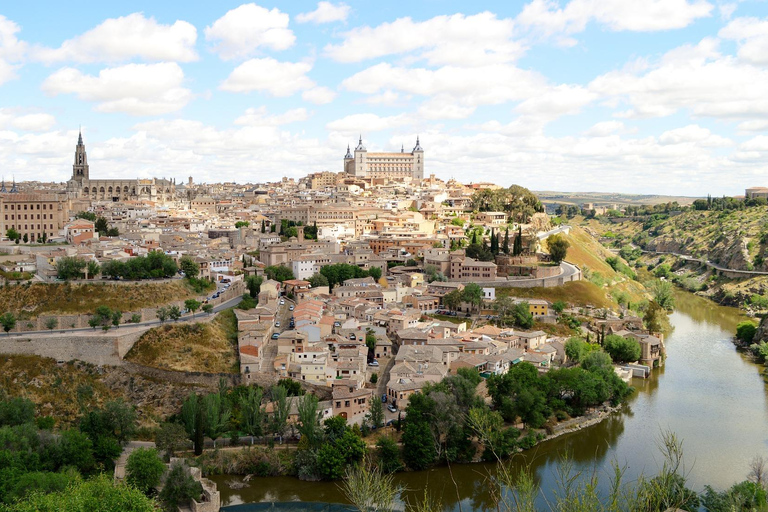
[{"left": 42, "top": 62, "right": 192, "bottom": 115}]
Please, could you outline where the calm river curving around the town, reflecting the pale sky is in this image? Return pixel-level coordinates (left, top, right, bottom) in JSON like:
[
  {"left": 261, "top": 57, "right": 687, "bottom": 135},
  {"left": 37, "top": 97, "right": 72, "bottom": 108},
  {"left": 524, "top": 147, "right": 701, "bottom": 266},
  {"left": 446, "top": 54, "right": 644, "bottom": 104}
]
[{"left": 213, "top": 292, "right": 768, "bottom": 511}]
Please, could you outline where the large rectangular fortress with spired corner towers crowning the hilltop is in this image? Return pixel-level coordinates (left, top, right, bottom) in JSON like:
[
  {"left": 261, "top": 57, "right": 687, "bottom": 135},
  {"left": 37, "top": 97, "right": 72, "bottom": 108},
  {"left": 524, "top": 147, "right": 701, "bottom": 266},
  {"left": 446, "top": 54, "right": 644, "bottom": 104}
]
[{"left": 344, "top": 136, "right": 424, "bottom": 180}]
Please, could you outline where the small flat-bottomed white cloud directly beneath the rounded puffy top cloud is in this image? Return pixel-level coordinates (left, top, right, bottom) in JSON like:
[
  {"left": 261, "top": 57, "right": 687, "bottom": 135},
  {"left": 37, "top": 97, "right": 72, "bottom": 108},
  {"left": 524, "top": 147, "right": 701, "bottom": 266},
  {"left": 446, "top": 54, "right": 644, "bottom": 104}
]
[{"left": 219, "top": 57, "right": 315, "bottom": 97}]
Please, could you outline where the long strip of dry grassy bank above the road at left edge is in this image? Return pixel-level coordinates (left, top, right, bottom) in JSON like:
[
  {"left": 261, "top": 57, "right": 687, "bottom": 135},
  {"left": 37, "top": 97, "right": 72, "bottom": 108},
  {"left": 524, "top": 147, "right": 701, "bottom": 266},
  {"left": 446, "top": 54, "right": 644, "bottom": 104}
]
[{"left": 0, "top": 280, "right": 201, "bottom": 317}]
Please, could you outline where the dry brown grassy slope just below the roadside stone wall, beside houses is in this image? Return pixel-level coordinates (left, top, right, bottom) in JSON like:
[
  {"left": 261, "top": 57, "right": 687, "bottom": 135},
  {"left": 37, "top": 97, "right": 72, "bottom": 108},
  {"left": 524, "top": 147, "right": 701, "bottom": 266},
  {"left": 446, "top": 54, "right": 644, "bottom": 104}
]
[{"left": 125, "top": 310, "right": 238, "bottom": 373}]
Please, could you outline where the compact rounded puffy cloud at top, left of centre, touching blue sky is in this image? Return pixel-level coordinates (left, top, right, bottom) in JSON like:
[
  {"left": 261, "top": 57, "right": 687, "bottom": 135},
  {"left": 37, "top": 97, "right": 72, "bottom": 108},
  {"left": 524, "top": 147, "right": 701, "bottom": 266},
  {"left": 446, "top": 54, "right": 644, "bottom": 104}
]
[{"left": 205, "top": 4, "right": 296, "bottom": 59}]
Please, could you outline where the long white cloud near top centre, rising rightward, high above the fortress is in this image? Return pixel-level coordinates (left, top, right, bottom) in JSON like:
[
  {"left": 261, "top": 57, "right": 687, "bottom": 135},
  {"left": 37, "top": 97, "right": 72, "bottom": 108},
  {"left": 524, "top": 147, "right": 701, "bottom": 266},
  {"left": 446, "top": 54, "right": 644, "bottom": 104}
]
[{"left": 324, "top": 12, "right": 524, "bottom": 66}]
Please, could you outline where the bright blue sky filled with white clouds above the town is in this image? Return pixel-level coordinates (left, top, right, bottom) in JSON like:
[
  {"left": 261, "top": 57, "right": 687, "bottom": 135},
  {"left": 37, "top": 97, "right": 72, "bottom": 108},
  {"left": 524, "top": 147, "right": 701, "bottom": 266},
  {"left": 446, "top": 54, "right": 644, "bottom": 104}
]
[{"left": 0, "top": 0, "right": 768, "bottom": 196}]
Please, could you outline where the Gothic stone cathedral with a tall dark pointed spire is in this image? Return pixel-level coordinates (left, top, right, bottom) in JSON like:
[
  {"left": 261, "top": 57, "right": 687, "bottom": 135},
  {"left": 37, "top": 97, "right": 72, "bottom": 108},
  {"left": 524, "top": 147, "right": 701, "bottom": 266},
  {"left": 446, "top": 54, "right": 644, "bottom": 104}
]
[{"left": 67, "top": 132, "right": 176, "bottom": 203}]
